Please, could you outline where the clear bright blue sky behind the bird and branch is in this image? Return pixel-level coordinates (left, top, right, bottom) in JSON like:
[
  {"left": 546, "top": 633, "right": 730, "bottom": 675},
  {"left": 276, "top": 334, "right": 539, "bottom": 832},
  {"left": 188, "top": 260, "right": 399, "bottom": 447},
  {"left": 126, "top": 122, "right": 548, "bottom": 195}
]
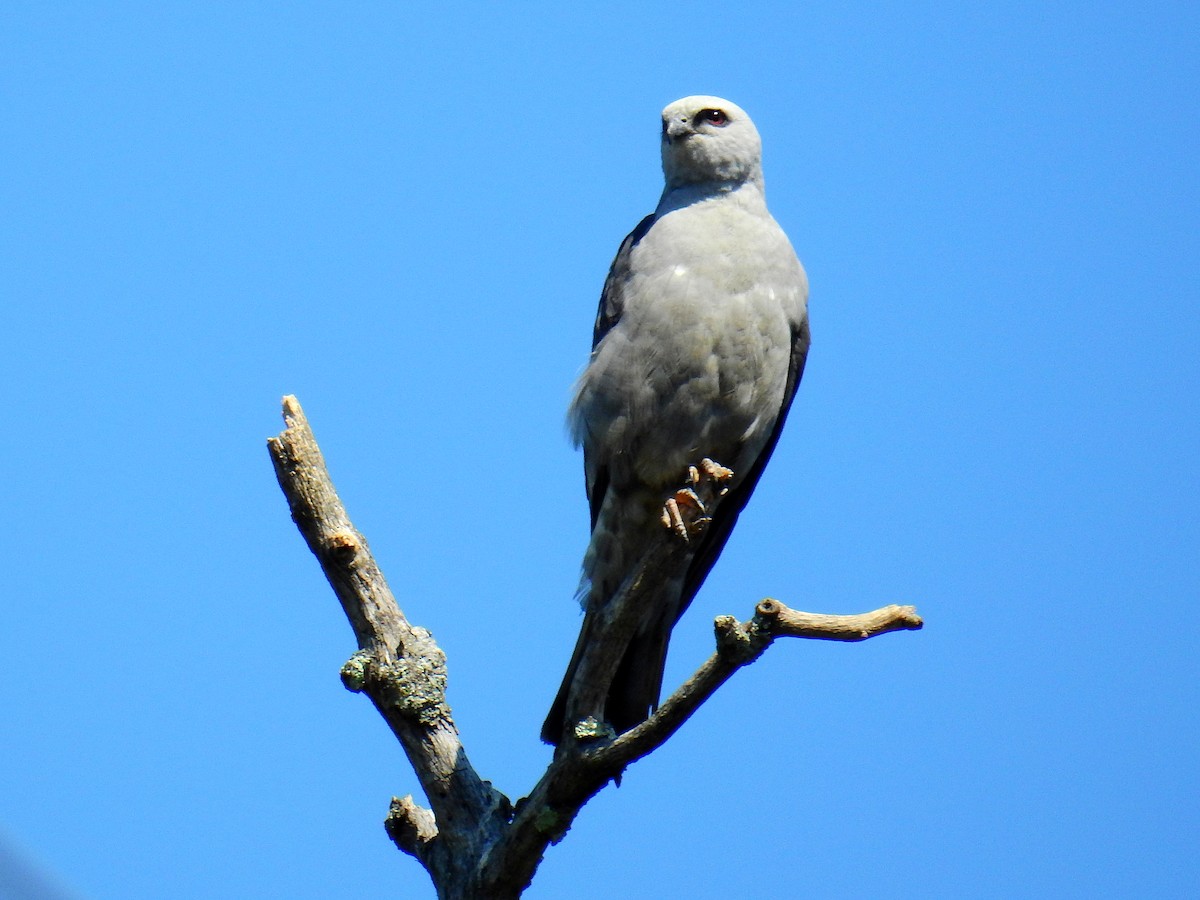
[{"left": 0, "top": 0, "right": 1200, "bottom": 900}]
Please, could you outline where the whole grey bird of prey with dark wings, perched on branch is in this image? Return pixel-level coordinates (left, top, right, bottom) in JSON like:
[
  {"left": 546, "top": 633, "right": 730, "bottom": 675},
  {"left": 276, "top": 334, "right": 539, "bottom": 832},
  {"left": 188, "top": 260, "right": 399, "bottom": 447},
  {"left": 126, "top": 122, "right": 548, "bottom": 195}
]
[{"left": 541, "top": 96, "right": 809, "bottom": 744}]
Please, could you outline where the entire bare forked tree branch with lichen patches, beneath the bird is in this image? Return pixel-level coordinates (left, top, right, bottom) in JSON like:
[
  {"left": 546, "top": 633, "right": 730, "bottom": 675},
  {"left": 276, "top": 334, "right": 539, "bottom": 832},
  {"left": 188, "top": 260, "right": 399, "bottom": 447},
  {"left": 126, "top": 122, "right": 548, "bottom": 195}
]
[{"left": 268, "top": 396, "right": 922, "bottom": 900}]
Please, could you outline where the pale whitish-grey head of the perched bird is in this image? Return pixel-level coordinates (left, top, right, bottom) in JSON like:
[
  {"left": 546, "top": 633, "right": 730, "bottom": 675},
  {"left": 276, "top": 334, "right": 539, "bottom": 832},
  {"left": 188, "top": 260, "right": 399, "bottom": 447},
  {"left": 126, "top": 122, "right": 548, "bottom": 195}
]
[{"left": 662, "top": 96, "right": 762, "bottom": 191}]
